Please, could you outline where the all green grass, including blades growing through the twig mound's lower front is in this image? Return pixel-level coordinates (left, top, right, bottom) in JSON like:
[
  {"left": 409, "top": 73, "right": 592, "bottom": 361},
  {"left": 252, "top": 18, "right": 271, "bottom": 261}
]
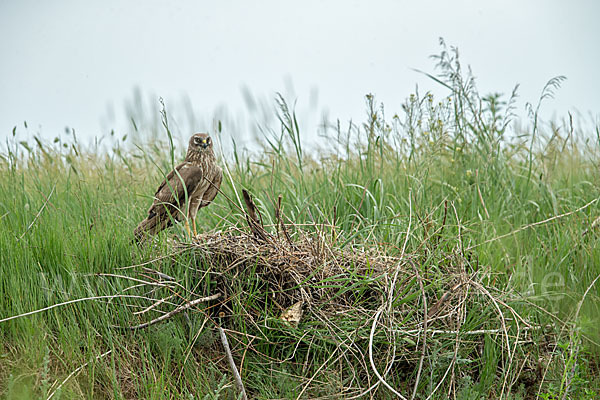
[{"left": 0, "top": 44, "right": 600, "bottom": 399}]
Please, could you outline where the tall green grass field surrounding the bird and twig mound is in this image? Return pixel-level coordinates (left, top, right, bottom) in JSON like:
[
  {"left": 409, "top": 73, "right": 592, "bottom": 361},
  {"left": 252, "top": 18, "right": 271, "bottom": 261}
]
[{"left": 0, "top": 54, "right": 600, "bottom": 399}]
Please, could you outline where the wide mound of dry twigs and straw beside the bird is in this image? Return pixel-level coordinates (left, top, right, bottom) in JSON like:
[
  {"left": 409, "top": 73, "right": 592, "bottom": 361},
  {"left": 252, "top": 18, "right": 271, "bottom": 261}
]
[{"left": 120, "top": 193, "right": 539, "bottom": 396}]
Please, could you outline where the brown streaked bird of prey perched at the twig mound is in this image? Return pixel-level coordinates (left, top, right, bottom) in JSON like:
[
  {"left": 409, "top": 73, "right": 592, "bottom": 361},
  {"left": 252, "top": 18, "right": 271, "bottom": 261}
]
[{"left": 133, "top": 133, "right": 223, "bottom": 242}]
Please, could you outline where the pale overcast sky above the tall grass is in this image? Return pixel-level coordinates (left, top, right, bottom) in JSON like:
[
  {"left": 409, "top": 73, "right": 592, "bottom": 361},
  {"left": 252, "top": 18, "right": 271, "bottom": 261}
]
[{"left": 0, "top": 0, "right": 600, "bottom": 146}]
